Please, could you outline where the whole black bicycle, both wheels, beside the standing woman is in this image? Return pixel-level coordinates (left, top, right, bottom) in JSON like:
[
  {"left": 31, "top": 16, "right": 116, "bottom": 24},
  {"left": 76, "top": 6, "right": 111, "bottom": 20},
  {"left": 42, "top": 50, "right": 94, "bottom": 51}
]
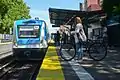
[{"left": 59, "top": 29, "right": 107, "bottom": 61}]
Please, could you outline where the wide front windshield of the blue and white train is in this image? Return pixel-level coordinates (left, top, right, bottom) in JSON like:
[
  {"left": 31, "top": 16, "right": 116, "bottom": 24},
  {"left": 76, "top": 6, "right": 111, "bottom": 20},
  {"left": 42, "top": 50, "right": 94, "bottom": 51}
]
[{"left": 18, "top": 26, "right": 40, "bottom": 38}]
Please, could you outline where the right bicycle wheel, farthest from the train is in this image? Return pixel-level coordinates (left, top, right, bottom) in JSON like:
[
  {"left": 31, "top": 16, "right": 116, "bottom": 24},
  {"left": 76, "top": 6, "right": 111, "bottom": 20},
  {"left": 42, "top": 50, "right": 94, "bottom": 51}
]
[{"left": 88, "top": 42, "right": 107, "bottom": 61}]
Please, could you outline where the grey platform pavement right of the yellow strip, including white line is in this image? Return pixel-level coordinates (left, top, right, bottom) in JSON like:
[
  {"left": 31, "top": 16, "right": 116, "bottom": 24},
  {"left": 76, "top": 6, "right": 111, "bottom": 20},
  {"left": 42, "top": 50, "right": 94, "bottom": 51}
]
[{"left": 56, "top": 48, "right": 120, "bottom": 80}]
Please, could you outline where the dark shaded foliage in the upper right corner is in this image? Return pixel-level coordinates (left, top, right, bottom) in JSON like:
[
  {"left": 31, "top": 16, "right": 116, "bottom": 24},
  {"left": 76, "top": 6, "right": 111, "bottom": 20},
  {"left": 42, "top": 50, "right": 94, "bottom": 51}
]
[{"left": 102, "top": 0, "right": 120, "bottom": 15}]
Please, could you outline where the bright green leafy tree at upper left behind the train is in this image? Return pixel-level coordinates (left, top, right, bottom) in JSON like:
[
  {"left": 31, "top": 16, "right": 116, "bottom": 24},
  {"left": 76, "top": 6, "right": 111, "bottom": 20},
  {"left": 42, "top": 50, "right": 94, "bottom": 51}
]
[{"left": 0, "top": 0, "right": 30, "bottom": 33}]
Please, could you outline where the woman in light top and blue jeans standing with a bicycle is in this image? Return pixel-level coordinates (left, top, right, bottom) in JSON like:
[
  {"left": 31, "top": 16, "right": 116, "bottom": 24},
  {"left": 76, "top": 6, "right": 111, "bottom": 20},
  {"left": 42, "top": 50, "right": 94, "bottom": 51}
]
[{"left": 73, "top": 17, "right": 87, "bottom": 61}]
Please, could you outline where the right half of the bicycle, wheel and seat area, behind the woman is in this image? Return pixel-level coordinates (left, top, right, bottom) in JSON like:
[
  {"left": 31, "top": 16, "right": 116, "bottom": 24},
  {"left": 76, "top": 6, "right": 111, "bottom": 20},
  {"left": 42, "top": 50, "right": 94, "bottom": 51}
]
[{"left": 88, "top": 36, "right": 108, "bottom": 61}]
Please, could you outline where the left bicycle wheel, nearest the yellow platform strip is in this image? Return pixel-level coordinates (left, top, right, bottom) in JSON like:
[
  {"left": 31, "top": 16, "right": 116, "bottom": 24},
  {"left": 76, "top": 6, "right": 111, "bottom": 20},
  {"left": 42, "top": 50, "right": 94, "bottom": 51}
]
[{"left": 59, "top": 43, "right": 76, "bottom": 61}]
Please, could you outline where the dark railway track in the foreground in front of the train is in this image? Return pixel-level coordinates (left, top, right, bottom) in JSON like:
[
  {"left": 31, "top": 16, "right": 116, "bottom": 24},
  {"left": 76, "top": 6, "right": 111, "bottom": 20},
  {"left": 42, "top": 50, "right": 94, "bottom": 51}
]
[{"left": 0, "top": 61, "right": 41, "bottom": 80}]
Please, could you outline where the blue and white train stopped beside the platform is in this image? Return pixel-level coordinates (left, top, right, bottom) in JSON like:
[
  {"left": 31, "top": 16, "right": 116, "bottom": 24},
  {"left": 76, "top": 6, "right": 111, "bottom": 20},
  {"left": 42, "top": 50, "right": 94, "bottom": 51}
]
[{"left": 13, "top": 19, "right": 49, "bottom": 60}]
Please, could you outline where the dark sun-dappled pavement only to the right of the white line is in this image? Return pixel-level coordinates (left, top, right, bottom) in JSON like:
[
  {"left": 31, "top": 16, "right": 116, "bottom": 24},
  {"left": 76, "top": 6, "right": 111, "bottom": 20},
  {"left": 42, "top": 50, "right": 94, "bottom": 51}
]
[{"left": 79, "top": 48, "right": 120, "bottom": 80}]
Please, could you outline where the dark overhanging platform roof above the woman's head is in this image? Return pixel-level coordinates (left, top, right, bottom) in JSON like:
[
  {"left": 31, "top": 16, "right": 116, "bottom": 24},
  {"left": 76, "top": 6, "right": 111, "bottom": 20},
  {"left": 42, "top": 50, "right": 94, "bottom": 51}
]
[{"left": 49, "top": 8, "right": 104, "bottom": 26}]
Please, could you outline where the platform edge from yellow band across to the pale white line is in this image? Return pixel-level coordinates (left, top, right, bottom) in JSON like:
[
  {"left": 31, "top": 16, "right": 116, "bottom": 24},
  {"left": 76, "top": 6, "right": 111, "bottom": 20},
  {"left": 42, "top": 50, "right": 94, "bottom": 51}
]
[{"left": 36, "top": 46, "right": 94, "bottom": 80}]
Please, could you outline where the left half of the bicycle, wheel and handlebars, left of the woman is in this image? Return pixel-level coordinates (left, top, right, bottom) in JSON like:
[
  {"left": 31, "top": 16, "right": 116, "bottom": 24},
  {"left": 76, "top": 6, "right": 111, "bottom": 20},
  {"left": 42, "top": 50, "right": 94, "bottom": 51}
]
[{"left": 59, "top": 29, "right": 76, "bottom": 61}]
